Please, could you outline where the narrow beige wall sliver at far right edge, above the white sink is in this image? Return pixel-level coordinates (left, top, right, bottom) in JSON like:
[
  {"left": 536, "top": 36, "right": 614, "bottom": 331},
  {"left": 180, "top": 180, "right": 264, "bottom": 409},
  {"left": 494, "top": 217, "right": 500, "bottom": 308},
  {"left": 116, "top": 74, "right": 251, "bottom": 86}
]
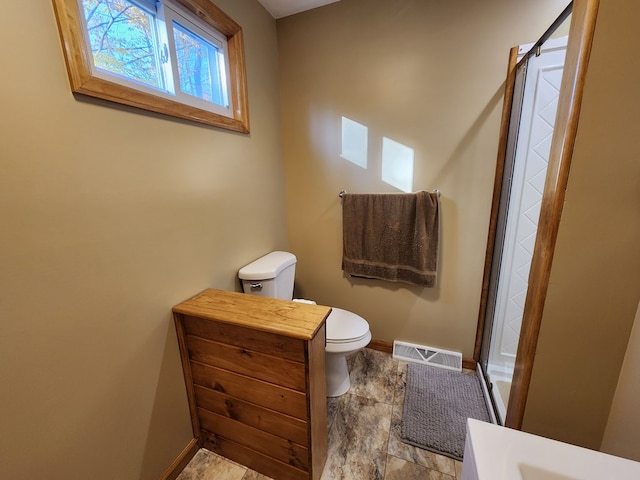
[{"left": 600, "top": 304, "right": 640, "bottom": 462}]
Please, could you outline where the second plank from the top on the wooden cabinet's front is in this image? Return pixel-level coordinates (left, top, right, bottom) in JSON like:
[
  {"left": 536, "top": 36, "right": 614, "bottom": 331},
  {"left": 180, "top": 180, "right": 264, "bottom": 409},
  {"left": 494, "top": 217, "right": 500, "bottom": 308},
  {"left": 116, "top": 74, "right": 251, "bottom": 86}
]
[{"left": 186, "top": 335, "right": 306, "bottom": 392}]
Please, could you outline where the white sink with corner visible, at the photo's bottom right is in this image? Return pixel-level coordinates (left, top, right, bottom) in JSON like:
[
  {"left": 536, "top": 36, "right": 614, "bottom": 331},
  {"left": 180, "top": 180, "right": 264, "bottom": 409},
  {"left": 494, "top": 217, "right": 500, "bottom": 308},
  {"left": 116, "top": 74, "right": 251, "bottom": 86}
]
[{"left": 462, "top": 418, "right": 640, "bottom": 480}]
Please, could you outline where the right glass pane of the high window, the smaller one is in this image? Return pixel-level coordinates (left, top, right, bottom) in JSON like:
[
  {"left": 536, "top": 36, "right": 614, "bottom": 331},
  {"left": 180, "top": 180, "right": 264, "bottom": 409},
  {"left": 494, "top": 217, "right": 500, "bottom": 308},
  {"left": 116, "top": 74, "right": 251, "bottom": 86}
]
[{"left": 173, "top": 22, "right": 228, "bottom": 107}]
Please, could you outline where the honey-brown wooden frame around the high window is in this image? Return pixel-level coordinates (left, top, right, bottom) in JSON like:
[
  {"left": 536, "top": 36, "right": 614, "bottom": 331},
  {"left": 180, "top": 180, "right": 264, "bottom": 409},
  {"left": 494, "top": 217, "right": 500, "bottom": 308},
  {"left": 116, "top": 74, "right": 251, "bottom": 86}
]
[{"left": 53, "top": 0, "right": 249, "bottom": 133}]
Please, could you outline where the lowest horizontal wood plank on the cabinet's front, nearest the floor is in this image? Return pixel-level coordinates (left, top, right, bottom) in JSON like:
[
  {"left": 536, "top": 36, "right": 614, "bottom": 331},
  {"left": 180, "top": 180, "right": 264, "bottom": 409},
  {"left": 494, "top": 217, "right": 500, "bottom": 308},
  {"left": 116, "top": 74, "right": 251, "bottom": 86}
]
[{"left": 202, "top": 431, "right": 310, "bottom": 480}]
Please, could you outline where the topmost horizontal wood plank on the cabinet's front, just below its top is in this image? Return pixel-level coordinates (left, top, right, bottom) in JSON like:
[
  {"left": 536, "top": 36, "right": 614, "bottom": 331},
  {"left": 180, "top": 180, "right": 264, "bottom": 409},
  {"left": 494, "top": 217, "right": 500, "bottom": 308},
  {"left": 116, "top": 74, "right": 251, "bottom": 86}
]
[{"left": 183, "top": 315, "right": 305, "bottom": 363}]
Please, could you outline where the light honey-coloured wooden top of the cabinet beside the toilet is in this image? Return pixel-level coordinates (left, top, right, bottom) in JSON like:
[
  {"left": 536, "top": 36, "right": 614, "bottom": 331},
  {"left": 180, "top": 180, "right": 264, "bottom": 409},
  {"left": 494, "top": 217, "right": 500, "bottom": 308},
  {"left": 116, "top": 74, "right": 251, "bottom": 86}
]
[{"left": 173, "top": 289, "right": 331, "bottom": 340}]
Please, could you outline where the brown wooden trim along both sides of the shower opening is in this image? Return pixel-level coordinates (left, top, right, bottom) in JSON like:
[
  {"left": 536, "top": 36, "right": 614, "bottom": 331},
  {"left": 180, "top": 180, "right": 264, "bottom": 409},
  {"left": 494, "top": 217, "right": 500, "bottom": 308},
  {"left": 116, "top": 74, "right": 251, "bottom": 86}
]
[{"left": 473, "top": 0, "right": 599, "bottom": 429}]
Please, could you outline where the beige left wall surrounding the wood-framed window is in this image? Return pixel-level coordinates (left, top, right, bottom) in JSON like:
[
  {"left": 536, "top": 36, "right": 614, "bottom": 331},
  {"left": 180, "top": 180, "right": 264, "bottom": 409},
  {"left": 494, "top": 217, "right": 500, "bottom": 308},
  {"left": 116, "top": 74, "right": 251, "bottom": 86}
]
[{"left": 0, "top": 0, "right": 288, "bottom": 480}]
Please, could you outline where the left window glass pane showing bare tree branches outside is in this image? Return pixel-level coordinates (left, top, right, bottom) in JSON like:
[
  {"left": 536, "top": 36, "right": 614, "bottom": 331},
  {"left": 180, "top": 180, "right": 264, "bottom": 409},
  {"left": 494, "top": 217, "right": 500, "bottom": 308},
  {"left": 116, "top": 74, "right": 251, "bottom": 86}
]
[{"left": 82, "top": 0, "right": 162, "bottom": 88}]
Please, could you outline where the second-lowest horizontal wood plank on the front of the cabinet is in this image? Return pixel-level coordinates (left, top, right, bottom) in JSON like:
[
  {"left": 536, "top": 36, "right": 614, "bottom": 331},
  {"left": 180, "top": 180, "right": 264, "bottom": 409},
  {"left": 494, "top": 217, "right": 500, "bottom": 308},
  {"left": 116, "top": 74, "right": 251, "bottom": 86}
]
[{"left": 198, "top": 409, "right": 309, "bottom": 471}]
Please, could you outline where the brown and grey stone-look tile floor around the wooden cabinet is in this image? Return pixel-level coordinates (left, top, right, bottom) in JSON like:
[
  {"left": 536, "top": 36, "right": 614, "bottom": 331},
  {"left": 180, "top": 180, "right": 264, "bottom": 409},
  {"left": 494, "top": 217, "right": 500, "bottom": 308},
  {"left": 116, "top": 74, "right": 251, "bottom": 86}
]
[{"left": 178, "top": 348, "right": 462, "bottom": 480}]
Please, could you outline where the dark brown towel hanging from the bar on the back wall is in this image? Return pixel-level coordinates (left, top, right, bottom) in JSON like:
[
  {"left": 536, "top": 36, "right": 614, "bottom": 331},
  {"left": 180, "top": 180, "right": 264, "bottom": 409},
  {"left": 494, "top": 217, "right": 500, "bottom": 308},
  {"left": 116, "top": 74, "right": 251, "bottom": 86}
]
[{"left": 342, "top": 192, "right": 439, "bottom": 287}]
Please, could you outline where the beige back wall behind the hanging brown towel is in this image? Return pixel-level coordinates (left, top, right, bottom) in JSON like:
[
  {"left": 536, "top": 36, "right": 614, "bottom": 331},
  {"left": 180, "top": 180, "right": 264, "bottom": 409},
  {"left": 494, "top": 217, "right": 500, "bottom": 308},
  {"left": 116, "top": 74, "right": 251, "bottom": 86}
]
[{"left": 278, "top": 0, "right": 568, "bottom": 357}]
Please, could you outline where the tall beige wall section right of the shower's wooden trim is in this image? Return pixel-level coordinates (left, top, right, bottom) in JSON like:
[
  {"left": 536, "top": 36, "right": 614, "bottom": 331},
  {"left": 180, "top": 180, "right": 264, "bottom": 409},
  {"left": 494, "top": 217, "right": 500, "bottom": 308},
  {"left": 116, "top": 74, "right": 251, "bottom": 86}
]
[{"left": 523, "top": 0, "right": 640, "bottom": 451}]
